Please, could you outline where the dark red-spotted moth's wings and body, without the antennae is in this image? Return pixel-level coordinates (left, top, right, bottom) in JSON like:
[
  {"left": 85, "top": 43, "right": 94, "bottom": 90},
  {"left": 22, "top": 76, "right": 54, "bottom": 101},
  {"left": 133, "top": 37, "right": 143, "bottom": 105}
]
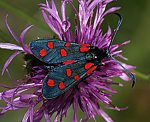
[{"left": 30, "top": 39, "right": 108, "bottom": 99}]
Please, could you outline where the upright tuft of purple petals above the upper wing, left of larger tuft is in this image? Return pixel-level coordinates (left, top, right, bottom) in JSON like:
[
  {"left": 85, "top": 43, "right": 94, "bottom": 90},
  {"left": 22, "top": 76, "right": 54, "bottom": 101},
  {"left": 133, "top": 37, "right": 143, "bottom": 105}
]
[{"left": 40, "top": 0, "right": 71, "bottom": 41}]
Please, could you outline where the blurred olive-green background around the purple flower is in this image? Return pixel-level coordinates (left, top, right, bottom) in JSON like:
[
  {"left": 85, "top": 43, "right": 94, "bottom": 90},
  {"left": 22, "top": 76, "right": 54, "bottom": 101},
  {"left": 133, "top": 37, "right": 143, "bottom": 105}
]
[{"left": 0, "top": 0, "right": 150, "bottom": 122}]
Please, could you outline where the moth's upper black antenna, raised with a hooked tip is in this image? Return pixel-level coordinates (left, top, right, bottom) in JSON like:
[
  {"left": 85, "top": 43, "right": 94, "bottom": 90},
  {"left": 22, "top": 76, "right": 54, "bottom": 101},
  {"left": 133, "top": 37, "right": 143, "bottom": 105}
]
[{"left": 108, "top": 13, "right": 123, "bottom": 50}]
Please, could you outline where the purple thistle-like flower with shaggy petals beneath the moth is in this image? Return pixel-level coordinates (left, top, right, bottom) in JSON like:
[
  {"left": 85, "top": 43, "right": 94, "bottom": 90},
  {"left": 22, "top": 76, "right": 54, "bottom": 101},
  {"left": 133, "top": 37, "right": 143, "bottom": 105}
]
[{"left": 0, "top": 0, "right": 135, "bottom": 122}]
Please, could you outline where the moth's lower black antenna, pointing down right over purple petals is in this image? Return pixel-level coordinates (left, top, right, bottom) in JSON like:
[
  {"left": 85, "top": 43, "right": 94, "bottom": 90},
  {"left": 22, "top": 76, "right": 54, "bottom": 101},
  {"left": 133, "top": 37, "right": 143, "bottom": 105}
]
[{"left": 110, "top": 56, "right": 136, "bottom": 87}]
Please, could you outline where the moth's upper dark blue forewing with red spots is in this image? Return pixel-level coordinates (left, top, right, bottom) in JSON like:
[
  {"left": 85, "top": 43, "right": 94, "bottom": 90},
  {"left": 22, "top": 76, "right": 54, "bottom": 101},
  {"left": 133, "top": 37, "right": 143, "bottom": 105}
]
[{"left": 30, "top": 39, "right": 90, "bottom": 64}]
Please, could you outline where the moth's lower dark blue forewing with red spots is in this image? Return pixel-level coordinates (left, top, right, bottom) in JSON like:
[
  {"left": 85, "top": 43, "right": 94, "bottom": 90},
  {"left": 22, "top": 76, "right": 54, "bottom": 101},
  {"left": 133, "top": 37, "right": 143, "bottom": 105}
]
[{"left": 43, "top": 60, "right": 97, "bottom": 99}]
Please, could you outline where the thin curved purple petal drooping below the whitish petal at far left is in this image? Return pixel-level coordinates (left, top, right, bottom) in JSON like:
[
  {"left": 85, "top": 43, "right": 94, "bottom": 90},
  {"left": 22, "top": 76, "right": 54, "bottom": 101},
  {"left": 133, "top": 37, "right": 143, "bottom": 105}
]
[{"left": 2, "top": 51, "right": 21, "bottom": 75}]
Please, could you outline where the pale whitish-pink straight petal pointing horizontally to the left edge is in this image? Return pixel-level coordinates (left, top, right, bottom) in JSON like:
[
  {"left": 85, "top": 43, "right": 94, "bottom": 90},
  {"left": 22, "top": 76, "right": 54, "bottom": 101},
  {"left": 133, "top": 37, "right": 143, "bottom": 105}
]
[{"left": 0, "top": 43, "right": 23, "bottom": 51}]
